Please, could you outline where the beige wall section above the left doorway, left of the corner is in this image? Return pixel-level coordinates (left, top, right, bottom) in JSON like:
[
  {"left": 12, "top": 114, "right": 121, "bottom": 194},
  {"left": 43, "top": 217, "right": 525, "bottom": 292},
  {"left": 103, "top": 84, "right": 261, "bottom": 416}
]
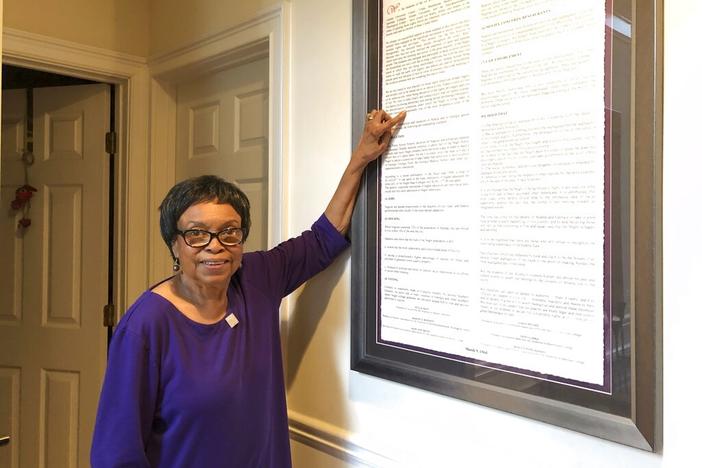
[{"left": 4, "top": 0, "right": 149, "bottom": 57}]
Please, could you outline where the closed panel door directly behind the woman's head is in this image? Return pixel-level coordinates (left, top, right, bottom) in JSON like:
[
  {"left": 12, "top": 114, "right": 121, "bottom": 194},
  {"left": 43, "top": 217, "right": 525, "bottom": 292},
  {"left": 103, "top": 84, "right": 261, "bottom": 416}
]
[{"left": 176, "top": 58, "right": 268, "bottom": 251}]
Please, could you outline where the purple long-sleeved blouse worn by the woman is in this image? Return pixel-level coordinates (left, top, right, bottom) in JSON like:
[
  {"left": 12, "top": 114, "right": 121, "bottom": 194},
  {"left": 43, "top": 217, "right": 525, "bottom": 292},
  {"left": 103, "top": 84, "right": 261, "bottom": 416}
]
[{"left": 91, "top": 215, "right": 348, "bottom": 468}]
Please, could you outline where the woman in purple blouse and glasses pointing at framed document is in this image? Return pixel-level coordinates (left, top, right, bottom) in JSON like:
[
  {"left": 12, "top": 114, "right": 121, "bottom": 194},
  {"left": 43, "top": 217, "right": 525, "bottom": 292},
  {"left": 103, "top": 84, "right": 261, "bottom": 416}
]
[{"left": 91, "top": 110, "right": 404, "bottom": 468}]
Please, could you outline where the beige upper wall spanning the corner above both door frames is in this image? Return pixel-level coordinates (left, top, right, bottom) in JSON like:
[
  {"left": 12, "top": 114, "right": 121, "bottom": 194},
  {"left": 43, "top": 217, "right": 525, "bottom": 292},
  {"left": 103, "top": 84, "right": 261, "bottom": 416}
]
[{"left": 4, "top": 0, "right": 280, "bottom": 57}]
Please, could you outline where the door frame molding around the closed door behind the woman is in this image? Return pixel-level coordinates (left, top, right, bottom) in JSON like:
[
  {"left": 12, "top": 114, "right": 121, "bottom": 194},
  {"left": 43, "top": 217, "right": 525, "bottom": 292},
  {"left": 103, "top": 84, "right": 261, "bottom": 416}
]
[{"left": 149, "top": 2, "right": 290, "bottom": 284}]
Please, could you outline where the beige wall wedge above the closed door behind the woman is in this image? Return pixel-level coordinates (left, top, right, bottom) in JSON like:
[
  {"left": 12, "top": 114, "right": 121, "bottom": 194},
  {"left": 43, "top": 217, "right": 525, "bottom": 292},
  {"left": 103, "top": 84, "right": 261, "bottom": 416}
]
[{"left": 149, "top": 0, "right": 281, "bottom": 56}]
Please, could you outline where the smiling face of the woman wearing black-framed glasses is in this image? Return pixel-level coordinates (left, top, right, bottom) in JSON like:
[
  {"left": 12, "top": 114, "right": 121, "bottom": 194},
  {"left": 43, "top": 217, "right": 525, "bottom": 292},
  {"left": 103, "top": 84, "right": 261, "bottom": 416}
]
[{"left": 173, "top": 201, "right": 244, "bottom": 287}]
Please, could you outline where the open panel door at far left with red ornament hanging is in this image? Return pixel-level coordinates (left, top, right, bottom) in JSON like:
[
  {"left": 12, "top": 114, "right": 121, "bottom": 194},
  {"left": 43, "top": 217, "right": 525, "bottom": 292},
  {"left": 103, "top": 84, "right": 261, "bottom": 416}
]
[{"left": 0, "top": 85, "right": 110, "bottom": 467}]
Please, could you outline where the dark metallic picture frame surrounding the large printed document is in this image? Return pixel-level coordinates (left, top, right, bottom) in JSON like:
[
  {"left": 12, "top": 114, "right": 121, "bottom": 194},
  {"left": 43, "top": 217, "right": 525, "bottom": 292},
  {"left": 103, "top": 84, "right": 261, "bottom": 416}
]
[{"left": 351, "top": 0, "right": 663, "bottom": 451}]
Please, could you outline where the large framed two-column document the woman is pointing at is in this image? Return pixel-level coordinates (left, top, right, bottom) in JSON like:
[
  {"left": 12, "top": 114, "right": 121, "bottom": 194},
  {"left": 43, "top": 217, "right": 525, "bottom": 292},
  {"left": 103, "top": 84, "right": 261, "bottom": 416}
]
[{"left": 352, "top": 0, "right": 662, "bottom": 450}]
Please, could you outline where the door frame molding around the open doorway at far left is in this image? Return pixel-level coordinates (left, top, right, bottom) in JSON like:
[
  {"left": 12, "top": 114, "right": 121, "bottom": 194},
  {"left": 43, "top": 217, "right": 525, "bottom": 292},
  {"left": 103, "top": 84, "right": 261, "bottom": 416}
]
[{"left": 2, "top": 28, "right": 150, "bottom": 313}]
